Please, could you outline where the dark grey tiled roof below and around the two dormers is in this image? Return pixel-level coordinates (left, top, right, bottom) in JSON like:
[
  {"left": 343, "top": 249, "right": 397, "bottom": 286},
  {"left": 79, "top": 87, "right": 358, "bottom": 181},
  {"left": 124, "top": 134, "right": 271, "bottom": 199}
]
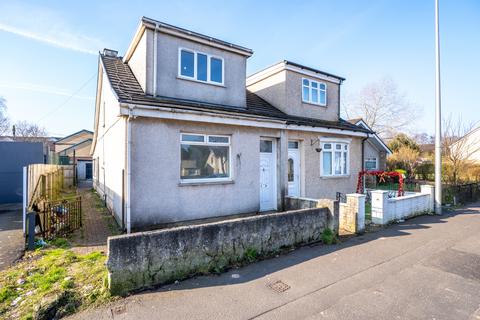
[{"left": 100, "top": 55, "right": 370, "bottom": 132}]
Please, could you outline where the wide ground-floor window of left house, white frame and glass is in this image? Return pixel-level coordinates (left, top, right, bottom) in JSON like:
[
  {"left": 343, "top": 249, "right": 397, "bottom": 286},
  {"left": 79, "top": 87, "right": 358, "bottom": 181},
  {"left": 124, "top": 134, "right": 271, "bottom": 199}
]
[{"left": 180, "top": 133, "right": 231, "bottom": 182}]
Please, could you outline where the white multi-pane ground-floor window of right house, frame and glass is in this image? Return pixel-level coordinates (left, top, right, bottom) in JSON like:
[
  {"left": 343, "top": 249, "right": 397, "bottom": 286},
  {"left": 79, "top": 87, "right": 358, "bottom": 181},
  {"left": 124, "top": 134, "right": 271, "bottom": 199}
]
[{"left": 320, "top": 141, "right": 350, "bottom": 177}]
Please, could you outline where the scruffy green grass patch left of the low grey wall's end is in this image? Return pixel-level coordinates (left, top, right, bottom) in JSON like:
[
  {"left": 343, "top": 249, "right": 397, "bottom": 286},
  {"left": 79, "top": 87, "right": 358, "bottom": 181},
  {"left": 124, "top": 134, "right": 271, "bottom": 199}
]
[{"left": 0, "top": 239, "right": 111, "bottom": 319}]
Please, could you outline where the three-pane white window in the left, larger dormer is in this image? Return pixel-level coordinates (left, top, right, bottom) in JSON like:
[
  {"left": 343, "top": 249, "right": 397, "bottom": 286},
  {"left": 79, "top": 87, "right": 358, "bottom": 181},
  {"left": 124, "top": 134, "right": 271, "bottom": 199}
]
[{"left": 178, "top": 48, "right": 225, "bottom": 85}]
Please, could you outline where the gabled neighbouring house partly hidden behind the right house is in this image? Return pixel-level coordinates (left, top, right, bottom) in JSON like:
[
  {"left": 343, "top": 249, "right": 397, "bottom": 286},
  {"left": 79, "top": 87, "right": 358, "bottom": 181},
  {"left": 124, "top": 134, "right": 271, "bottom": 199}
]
[{"left": 348, "top": 118, "right": 392, "bottom": 170}]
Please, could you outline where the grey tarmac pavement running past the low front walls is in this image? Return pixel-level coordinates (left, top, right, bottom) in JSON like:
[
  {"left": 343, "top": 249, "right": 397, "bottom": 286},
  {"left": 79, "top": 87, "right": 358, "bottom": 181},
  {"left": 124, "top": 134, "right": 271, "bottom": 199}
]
[{"left": 74, "top": 206, "right": 480, "bottom": 320}]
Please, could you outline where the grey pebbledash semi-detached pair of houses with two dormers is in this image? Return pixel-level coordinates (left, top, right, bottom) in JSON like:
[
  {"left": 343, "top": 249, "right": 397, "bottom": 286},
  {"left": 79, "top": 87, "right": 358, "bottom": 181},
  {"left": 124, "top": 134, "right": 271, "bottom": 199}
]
[{"left": 91, "top": 17, "right": 373, "bottom": 232}]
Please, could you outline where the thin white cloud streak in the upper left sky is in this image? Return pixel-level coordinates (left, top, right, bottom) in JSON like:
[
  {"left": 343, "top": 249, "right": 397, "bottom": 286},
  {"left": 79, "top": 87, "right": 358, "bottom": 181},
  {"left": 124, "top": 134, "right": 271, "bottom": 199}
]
[{"left": 0, "top": 3, "right": 103, "bottom": 55}]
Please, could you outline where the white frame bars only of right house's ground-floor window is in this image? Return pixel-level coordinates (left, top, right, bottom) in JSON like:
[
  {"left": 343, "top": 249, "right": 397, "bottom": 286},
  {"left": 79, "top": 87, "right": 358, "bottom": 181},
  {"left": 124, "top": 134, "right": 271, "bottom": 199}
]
[{"left": 320, "top": 139, "right": 351, "bottom": 178}]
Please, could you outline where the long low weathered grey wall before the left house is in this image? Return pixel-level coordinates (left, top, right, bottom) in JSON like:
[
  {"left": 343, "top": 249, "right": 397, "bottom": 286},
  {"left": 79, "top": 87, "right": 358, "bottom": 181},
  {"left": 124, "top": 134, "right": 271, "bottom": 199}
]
[{"left": 107, "top": 207, "right": 338, "bottom": 294}]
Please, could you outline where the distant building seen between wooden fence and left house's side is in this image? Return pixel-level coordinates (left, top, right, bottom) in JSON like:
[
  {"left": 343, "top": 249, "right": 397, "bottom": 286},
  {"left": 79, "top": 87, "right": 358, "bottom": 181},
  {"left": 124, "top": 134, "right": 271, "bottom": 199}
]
[{"left": 52, "top": 129, "right": 93, "bottom": 181}]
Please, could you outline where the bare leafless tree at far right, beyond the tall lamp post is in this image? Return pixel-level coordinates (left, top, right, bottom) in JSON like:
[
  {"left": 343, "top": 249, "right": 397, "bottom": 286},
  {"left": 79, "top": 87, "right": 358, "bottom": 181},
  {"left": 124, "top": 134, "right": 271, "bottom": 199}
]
[{"left": 442, "top": 115, "right": 480, "bottom": 184}]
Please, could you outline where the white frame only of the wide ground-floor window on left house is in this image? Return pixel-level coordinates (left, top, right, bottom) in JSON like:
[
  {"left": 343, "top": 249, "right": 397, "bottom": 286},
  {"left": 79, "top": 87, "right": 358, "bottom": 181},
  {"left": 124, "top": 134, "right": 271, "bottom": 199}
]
[{"left": 179, "top": 132, "right": 233, "bottom": 184}]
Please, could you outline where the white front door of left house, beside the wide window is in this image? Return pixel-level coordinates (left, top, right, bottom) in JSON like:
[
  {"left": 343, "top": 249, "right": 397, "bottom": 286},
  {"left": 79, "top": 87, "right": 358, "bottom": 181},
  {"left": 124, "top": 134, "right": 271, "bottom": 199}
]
[{"left": 260, "top": 139, "right": 277, "bottom": 211}]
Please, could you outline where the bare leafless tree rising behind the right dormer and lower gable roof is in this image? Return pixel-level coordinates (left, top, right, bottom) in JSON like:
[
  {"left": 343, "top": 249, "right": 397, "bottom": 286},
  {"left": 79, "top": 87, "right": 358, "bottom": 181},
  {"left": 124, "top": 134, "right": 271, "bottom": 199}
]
[{"left": 343, "top": 78, "right": 418, "bottom": 138}]
